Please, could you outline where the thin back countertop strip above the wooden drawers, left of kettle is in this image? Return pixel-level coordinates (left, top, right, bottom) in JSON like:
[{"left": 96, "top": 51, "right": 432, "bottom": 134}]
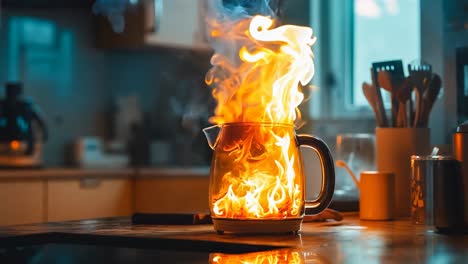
[{"left": 0, "top": 166, "right": 210, "bottom": 180}]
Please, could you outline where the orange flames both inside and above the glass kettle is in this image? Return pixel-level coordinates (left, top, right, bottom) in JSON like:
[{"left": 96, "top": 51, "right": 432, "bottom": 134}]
[{"left": 206, "top": 16, "right": 315, "bottom": 219}]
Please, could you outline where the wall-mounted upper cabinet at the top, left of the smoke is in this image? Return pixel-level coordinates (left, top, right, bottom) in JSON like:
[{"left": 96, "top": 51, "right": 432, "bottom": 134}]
[{"left": 96, "top": 0, "right": 210, "bottom": 51}]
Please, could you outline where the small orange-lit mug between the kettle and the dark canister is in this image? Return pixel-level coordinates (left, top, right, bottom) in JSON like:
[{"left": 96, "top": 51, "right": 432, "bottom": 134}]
[{"left": 359, "top": 171, "right": 395, "bottom": 220}]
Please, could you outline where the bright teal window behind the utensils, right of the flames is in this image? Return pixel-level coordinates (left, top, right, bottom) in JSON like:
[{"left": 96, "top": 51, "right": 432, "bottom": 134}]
[{"left": 310, "top": 0, "right": 421, "bottom": 118}]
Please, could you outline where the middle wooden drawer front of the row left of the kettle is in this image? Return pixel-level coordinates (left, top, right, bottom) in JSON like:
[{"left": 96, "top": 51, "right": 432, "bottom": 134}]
[{"left": 47, "top": 178, "right": 133, "bottom": 221}]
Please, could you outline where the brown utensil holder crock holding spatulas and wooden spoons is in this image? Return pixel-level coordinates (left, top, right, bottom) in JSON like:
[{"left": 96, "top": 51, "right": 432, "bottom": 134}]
[{"left": 375, "top": 127, "right": 430, "bottom": 217}]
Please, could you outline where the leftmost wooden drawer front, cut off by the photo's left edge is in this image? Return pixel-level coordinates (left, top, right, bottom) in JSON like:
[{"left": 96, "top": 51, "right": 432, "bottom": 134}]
[{"left": 0, "top": 179, "right": 46, "bottom": 226}]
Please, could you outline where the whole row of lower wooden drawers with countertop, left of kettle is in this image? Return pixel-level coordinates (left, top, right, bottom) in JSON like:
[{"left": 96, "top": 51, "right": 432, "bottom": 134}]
[{"left": 0, "top": 167, "right": 209, "bottom": 226}]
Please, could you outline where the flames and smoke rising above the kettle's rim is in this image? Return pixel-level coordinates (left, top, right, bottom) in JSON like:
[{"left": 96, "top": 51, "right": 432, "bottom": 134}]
[{"left": 205, "top": 0, "right": 315, "bottom": 125}]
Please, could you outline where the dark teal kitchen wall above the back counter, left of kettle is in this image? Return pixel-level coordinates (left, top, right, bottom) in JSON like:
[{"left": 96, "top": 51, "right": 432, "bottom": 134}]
[{"left": 0, "top": 9, "right": 209, "bottom": 166}]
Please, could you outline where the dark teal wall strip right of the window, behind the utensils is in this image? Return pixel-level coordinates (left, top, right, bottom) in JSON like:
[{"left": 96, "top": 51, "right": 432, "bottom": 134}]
[{"left": 421, "top": 0, "right": 468, "bottom": 144}]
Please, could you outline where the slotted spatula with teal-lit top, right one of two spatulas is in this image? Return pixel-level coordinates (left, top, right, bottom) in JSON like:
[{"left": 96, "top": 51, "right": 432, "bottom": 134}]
[{"left": 408, "top": 61, "right": 432, "bottom": 127}]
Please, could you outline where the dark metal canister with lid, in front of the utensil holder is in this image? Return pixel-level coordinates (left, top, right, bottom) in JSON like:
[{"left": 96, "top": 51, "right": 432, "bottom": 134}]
[{"left": 411, "top": 155, "right": 464, "bottom": 231}]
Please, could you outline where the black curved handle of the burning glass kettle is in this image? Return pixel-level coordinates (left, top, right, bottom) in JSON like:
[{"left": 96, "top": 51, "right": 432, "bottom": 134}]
[{"left": 297, "top": 135, "right": 335, "bottom": 215}]
